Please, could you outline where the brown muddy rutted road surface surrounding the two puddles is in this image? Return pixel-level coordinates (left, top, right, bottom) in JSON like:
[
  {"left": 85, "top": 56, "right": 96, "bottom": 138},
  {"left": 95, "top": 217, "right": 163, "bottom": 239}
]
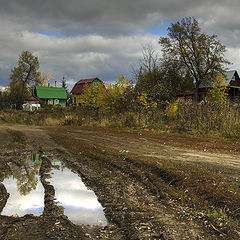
[{"left": 0, "top": 125, "right": 240, "bottom": 240}]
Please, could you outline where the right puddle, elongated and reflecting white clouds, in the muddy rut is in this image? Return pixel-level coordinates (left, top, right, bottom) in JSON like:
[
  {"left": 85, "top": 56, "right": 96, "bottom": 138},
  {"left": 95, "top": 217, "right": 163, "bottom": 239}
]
[{"left": 48, "top": 160, "right": 107, "bottom": 225}]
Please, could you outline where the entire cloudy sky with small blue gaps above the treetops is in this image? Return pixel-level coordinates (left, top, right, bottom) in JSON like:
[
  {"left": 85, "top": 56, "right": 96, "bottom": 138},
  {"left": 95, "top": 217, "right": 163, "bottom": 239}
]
[{"left": 0, "top": 0, "right": 240, "bottom": 89}]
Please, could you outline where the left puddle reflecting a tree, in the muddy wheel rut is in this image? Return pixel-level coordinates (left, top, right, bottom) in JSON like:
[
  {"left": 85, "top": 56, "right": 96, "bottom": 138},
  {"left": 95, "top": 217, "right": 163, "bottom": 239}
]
[{"left": 1, "top": 161, "right": 44, "bottom": 217}]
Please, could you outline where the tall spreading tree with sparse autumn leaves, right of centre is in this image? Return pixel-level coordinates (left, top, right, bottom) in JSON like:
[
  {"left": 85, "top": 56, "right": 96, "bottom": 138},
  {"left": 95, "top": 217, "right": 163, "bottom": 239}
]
[{"left": 159, "top": 17, "right": 229, "bottom": 99}]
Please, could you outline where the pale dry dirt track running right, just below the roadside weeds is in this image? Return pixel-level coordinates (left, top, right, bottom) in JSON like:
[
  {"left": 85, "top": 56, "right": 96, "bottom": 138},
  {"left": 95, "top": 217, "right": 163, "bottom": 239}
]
[{"left": 55, "top": 128, "right": 240, "bottom": 176}]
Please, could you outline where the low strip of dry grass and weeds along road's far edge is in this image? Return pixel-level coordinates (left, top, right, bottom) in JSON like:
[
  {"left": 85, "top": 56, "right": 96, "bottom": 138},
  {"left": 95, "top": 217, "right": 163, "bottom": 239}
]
[{"left": 0, "top": 102, "right": 240, "bottom": 138}]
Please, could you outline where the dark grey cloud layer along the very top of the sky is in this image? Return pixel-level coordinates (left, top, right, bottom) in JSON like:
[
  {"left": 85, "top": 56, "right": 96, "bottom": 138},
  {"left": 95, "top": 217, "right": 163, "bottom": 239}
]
[{"left": 0, "top": 0, "right": 239, "bottom": 35}]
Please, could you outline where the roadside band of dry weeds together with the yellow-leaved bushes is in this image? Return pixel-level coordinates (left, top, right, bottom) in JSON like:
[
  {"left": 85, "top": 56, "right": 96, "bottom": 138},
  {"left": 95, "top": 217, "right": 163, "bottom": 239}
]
[{"left": 0, "top": 86, "right": 240, "bottom": 138}]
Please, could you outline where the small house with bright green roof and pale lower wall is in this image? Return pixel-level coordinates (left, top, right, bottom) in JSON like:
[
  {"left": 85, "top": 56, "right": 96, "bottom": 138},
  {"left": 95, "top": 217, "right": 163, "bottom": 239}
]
[{"left": 34, "top": 86, "right": 67, "bottom": 106}]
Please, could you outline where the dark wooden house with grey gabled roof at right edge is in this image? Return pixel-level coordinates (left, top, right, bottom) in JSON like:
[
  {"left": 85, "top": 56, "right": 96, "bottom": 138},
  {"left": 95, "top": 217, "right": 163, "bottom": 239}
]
[{"left": 199, "top": 70, "right": 240, "bottom": 101}]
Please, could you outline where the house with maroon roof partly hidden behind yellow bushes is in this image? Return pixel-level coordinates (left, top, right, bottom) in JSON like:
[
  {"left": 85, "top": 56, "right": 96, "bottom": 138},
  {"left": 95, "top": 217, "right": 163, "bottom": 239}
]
[{"left": 71, "top": 77, "right": 102, "bottom": 105}]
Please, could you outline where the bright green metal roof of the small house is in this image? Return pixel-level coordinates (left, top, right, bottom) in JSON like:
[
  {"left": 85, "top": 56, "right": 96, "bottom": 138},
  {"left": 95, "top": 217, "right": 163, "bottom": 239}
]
[{"left": 36, "top": 86, "right": 67, "bottom": 99}]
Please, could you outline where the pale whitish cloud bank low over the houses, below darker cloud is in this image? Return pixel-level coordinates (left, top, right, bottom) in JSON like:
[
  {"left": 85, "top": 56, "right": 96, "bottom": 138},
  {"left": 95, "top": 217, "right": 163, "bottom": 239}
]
[{"left": 0, "top": 28, "right": 159, "bottom": 87}]
